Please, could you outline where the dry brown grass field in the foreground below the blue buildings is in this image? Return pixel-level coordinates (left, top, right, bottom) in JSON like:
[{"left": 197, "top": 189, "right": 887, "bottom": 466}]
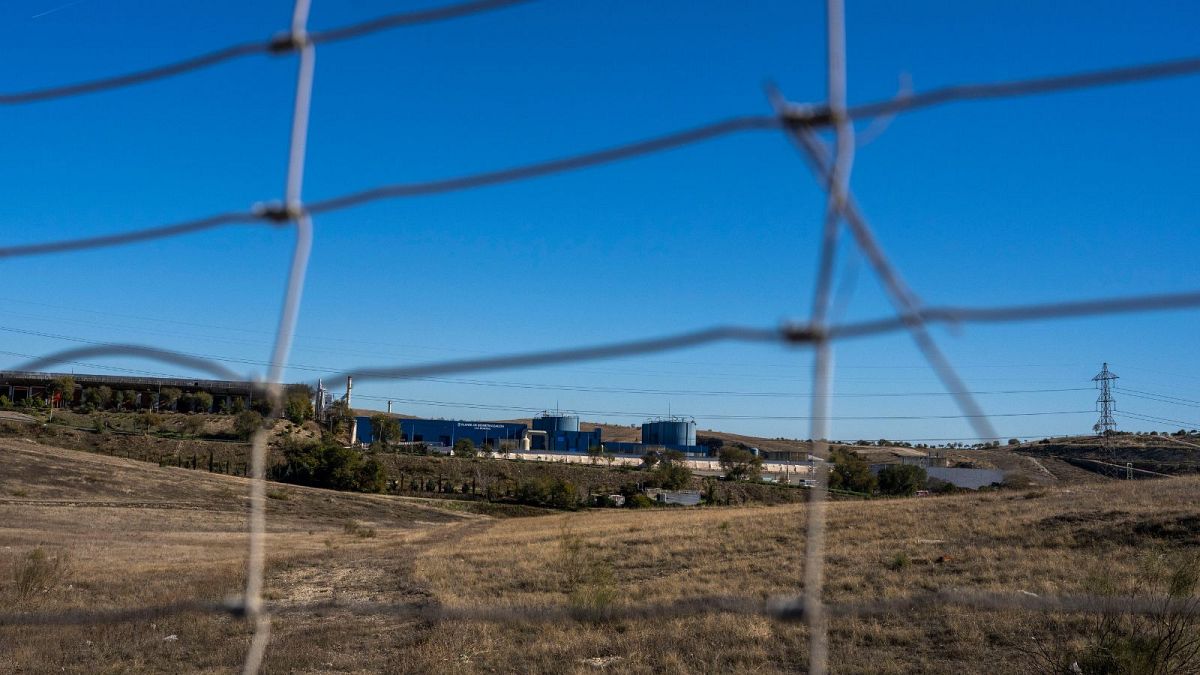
[{"left": 0, "top": 432, "right": 1200, "bottom": 673}]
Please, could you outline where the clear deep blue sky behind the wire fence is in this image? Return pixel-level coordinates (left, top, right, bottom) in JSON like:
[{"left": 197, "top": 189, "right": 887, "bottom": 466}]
[{"left": 0, "top": 0, "right": 1200, "bottom": 438}]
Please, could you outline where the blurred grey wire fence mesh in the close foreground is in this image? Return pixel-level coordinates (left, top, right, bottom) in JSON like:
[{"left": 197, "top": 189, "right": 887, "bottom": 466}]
[{"left": 0, "top": 0, "right": 1200, "bottom": 673}]
